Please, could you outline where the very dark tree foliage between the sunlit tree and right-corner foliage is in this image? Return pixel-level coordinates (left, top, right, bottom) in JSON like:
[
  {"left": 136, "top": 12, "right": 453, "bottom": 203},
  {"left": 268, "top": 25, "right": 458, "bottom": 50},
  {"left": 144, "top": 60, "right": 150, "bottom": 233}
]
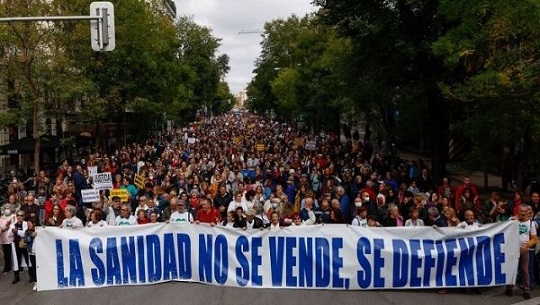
[{"left": 314, "top": 0, "right": 449, "bottom": 180}]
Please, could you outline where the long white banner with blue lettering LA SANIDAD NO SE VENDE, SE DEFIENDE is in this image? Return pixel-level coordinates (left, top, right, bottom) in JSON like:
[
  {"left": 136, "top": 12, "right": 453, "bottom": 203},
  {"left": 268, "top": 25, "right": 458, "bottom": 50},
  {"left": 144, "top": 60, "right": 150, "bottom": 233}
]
[{"left": 36, "top": 222, "right": 520, "bottom": 290}]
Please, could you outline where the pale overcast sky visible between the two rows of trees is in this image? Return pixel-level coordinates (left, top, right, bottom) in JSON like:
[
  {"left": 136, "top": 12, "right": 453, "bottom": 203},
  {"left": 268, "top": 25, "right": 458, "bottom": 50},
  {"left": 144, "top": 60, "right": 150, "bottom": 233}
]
[{"left": 176, "top": 0, "right": 315, "bottom": 94}]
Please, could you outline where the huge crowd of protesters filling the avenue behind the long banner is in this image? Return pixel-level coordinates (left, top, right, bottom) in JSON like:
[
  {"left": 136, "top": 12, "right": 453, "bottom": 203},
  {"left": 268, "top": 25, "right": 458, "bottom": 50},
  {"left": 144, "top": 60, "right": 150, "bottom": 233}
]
[{"left": 0, "top": 113, "right": 540, "bottom": 298}]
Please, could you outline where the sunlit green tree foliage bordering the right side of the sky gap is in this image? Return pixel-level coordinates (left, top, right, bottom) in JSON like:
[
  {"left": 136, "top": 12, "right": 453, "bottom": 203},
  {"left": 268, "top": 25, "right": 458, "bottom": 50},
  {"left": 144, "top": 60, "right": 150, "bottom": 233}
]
[{"left": 248, "top": 15, "right": 350, "bottom": 130}]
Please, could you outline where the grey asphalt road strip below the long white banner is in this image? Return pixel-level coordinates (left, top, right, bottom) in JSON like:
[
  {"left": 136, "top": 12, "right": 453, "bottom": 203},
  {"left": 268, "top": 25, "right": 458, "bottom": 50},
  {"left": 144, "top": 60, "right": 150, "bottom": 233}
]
[{"left": 0, "top": 272, "right": 540, "bottom": 305}]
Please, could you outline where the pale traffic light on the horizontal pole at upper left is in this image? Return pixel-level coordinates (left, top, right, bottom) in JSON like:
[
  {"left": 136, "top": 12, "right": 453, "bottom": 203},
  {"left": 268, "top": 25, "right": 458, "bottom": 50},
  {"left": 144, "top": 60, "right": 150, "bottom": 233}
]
[{"left": 90, "top": 2, "right": 116, "bottom": 52}]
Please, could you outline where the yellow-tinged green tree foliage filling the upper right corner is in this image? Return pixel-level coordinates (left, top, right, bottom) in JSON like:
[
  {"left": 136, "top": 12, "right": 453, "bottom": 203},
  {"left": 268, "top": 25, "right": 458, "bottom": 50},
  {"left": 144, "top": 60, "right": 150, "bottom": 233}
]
[{"left": 433, "top": 0, "right": 540, "bottom": 184}]
